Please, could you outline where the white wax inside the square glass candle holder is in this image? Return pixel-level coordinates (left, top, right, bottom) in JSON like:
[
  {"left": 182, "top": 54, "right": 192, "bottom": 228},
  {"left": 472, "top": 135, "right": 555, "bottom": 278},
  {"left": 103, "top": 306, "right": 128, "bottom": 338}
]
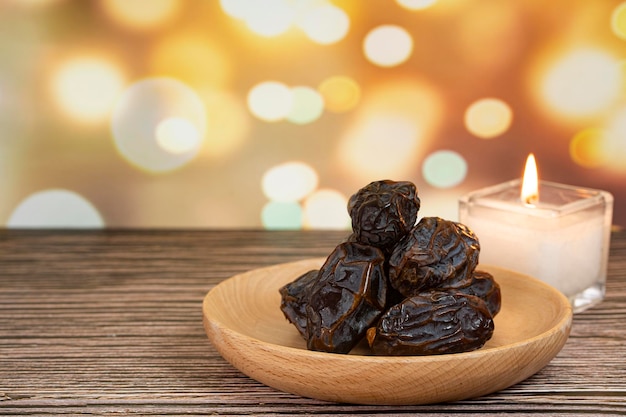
[{"left": 462, "top": 209, "right": 604, "bottom": 297}]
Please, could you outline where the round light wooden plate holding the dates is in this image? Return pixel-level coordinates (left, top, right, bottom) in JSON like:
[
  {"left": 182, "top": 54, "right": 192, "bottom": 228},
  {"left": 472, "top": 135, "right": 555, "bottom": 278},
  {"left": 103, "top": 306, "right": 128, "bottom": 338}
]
[{"left": 202, "top": 258, "right": 572, "bottom": 404}]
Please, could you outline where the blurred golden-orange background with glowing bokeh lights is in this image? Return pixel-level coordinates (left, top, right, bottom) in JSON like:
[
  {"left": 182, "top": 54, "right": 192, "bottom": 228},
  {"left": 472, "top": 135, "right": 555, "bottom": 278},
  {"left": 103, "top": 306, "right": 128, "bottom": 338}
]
[{"left": 0, "top": 0, "right": 626, "bottom": 229}]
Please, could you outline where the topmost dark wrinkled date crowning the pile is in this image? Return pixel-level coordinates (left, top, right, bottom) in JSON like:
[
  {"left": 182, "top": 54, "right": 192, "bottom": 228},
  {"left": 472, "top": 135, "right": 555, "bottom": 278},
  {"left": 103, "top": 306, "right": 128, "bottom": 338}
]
[{"left": 348, "top": 180, "right": 420, "bottom": 251}]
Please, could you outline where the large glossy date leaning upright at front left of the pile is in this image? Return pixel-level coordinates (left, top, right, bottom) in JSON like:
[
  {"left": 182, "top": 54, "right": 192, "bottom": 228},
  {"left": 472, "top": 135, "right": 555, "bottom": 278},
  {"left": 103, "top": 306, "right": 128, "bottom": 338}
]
[{"left": 306, "top": 242, "right": 387, "bottom": 353}]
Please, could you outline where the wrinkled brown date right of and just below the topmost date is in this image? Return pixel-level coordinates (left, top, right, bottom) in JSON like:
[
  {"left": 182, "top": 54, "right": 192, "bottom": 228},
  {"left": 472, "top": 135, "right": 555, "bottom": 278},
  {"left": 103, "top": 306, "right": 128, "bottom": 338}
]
[{"left": 389, "top": 217, "right": 480, "bottom": 297}]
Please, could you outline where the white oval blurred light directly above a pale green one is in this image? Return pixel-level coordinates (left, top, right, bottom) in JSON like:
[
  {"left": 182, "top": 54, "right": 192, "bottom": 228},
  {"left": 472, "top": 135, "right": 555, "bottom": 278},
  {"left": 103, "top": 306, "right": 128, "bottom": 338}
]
[{"left": 261, "top": 161, "right": 318, "bottom": 202}]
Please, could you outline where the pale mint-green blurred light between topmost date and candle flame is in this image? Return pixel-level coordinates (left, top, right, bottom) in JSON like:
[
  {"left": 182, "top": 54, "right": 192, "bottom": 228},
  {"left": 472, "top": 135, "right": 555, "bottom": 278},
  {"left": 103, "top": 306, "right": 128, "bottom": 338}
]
[{"left": 422, "top": 150, "right": 467, "bottom": 188}]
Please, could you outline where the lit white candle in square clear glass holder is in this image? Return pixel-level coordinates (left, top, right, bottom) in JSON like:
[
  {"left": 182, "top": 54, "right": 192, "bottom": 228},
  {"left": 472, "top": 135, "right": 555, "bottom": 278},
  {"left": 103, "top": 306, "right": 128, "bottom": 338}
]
[{"left": 459, "top": 154, "right": 613, "bottom": 312}]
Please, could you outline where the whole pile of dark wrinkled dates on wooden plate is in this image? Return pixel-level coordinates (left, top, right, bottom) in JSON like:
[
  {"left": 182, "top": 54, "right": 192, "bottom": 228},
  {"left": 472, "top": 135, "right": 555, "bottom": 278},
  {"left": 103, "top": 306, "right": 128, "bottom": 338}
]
[{"left": 280, "top": 180, "right": 501, "bottom": 355}]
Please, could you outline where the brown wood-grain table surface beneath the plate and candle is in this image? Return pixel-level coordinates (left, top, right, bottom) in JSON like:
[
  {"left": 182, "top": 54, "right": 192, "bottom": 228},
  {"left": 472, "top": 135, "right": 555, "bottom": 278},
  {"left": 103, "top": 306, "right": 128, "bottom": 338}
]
[{"left": 0, "top": 230, "right": 626, "bottom": 416}]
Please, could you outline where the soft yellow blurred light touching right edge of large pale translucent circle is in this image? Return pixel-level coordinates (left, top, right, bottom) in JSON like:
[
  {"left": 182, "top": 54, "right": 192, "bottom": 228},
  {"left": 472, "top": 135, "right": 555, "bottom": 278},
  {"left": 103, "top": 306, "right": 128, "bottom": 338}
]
[{"left": 202, "top": 91, "right": 250, "bottom": 157}]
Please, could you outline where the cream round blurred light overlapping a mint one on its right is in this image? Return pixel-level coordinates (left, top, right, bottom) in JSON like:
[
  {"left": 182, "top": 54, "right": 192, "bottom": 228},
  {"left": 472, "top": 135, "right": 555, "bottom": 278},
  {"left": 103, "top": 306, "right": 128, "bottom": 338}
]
[{"left": 248, "top": 81, "right": 293, "bottom": 122}]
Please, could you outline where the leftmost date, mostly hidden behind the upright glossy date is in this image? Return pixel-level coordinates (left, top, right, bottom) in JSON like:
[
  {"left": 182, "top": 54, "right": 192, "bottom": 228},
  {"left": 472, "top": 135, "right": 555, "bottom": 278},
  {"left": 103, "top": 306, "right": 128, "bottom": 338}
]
[{"left": 279, "top": 269, "right": 319, "bottom": 339}]
